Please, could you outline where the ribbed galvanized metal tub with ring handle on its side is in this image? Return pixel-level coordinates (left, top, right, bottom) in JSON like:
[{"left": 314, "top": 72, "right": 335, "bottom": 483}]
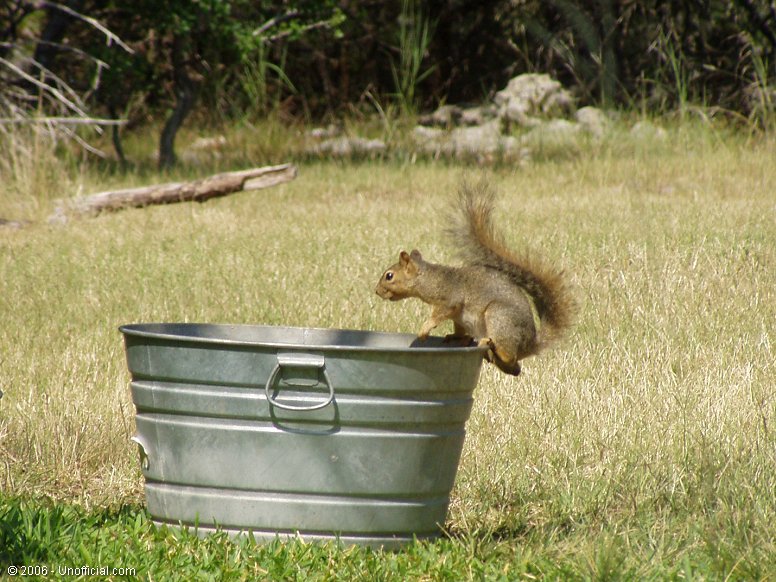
[{"left": 120, "top": 323, "right": 483, "bottom": 548}]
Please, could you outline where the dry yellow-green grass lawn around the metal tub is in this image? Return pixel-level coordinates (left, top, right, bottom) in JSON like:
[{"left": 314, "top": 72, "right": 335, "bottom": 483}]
[{"left": 0, "top": 124, "right": 776, "bottom": 580}]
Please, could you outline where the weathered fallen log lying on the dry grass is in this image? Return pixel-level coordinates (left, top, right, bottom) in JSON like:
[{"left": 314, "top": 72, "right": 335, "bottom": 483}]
[{"left": 49, "top": 164, "right": 297, "bottom": 222}]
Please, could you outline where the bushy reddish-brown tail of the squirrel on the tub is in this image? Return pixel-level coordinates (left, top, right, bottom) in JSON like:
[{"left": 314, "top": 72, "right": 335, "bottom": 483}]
[{"left": 448, "top": 180, "right": 577, "bottom": 343}]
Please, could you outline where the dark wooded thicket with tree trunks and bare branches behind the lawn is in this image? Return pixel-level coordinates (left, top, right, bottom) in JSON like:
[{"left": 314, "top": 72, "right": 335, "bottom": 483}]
[{"left": 0, "top": 0, "right": 776, "bottom": 168}]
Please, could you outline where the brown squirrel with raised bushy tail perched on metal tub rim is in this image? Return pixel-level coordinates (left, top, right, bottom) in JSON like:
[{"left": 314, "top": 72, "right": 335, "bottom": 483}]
[{"left": 375, "top": 181, "right": 576, "bottom": 376}]
